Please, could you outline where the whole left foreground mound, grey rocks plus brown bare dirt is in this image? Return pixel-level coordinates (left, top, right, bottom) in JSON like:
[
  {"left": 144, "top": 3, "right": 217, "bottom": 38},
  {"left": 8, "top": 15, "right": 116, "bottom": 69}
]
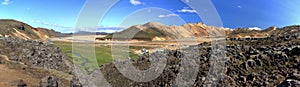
[{"left": 0, "top": 38, "right": 80, "bottom": 87}]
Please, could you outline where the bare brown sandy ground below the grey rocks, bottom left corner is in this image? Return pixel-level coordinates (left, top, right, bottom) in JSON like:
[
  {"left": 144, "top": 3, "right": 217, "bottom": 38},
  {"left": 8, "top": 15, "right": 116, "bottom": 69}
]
[{"left": 0, "top": 55, "right": 72, "bottom": 87}]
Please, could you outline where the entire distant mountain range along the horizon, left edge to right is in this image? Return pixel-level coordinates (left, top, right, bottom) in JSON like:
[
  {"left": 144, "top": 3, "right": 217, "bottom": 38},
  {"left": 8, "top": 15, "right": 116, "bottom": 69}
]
[{"left": 0, "top": 19, "right": 300, "bottom": 41}]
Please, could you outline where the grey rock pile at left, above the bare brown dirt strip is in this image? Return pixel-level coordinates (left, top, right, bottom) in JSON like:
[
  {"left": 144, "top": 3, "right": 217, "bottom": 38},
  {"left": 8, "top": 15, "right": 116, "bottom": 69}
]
[{"left": 0, "top": 38, "right": 71, "bottom": 72}]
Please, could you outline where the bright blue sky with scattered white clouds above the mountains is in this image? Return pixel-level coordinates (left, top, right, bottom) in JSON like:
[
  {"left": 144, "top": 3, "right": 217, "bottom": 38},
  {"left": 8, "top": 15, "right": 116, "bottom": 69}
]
[{"left": 0, "top": 0, "right": 300, "bottom": 33}]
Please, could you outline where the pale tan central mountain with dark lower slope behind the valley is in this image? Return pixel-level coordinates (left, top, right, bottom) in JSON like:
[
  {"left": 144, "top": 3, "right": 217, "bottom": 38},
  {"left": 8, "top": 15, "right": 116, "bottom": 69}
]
[{"left": 105, "top": 22, "right": 229, "bottom": 41}]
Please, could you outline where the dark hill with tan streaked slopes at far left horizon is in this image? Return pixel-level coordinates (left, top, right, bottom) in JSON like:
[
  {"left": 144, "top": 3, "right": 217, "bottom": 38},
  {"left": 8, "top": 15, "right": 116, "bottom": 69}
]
[{"left": 0, "top": 19, "right": 61, "bottom": 40}]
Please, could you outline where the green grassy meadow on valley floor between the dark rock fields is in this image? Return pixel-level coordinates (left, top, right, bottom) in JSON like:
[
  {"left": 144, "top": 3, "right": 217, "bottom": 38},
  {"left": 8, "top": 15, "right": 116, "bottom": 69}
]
[{"left": 54, "top": 41, "right": 138, "bottom": 74}]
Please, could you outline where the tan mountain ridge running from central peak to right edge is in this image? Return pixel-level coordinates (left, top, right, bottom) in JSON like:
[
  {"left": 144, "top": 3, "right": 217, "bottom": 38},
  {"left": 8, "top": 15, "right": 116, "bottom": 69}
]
[{"left": 102, "top": 22, "right": 300, "bottom": 41}]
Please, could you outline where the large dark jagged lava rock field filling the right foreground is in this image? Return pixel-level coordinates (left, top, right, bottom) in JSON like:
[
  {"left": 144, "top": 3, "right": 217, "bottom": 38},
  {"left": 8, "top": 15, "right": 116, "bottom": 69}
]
[{"left": 101, "top": 37, "right": 300, "bottom": 87}]
